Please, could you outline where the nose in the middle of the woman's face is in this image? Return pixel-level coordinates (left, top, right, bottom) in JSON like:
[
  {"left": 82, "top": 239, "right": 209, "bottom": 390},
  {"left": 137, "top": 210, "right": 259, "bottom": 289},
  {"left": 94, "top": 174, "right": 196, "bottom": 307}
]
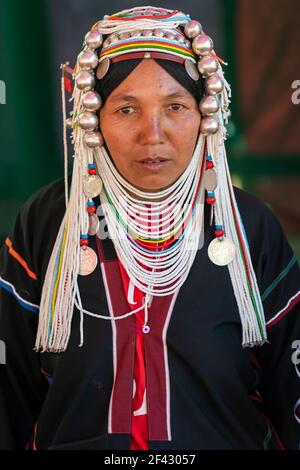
[{"left": 139, "top": 111, "right": 165, "bottom": 145}]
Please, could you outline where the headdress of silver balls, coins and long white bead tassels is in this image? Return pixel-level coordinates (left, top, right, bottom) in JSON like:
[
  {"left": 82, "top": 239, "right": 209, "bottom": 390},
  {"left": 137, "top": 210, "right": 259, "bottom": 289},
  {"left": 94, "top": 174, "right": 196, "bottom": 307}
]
[{"left": 36, "top": 7, "right": 266, "bottom": 351}]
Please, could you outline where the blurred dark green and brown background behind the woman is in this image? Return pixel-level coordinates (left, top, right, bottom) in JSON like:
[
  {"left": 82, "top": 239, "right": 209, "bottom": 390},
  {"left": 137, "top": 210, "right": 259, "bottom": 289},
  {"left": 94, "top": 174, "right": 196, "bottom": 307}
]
[{"left": 0, "top": 0, "right": 300, "bottom": 259}]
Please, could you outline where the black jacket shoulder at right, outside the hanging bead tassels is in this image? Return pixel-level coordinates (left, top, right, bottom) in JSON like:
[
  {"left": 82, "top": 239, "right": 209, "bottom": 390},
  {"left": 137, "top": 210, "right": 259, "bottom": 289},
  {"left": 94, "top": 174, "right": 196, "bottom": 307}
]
[{"left": 234, "top": 188, "right": 300, "bottom": 328}]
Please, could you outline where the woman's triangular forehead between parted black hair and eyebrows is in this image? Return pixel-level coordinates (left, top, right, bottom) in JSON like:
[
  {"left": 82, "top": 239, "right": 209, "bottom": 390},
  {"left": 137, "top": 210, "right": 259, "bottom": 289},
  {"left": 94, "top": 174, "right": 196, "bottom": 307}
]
[{"left": 110, "top": 59, "right": 189, "bottom": 100}]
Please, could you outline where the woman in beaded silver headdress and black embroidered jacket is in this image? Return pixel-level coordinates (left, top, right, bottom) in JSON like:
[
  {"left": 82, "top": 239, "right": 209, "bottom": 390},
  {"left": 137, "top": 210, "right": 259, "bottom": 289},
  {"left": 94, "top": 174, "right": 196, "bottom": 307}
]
[{"left": 0, "top": 7, "right": 300, "bottom": 450}]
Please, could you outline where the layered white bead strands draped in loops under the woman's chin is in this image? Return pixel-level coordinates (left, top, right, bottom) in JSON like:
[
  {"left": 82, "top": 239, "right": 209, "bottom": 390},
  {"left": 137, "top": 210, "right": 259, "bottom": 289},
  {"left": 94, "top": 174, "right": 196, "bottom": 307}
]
[{"left": 95, "top": 135, "right": 204, "bottom": 296}]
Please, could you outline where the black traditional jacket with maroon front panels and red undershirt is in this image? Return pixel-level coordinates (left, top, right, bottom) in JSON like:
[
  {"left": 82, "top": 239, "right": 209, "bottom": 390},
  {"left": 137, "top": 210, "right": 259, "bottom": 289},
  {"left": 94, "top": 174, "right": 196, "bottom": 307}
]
[{"left": 0, "top": 178, "right": 300, "bottom": 449}]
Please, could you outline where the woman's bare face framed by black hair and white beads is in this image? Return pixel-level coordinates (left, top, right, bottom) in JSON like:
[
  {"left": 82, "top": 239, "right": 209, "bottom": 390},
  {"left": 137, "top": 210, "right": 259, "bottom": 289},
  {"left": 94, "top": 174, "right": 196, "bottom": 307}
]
[{"left": 100, "top": 59, "right": 201, "bottom": 191}]
